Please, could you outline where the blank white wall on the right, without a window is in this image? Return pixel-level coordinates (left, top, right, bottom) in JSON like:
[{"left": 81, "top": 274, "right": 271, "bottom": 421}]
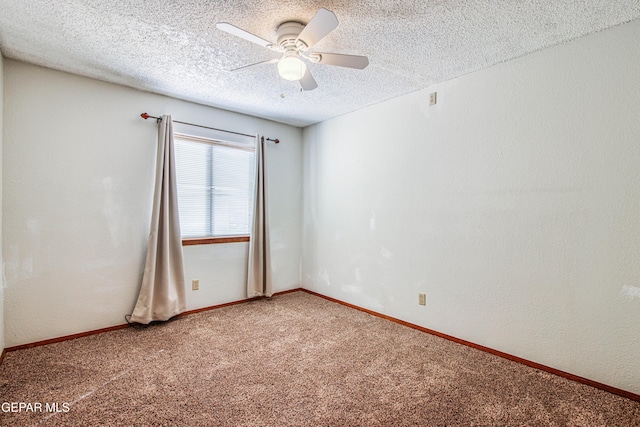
[{"left": 302, "top": 21, "right": 640, "bottom": 393}]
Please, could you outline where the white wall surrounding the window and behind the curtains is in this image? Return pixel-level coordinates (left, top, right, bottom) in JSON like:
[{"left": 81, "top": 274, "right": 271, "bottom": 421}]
[{"left": 3, "top": 60, "right": 302, "bottom": 347}]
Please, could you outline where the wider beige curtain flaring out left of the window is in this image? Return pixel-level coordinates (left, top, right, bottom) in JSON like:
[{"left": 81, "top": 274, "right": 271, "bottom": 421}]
[{"left": 130, "top": 115, "right": 186, "bottom": 325}]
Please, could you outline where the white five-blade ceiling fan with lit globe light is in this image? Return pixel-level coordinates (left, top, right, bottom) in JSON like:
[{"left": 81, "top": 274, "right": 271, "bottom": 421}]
[{"left": 216, "top": 8, "right": 369, "bottom": 90}]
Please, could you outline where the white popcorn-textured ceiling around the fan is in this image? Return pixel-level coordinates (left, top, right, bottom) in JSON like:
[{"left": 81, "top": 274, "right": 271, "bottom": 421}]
[{"left": 0, "top": 0, "right": 640, "bottom": 126}]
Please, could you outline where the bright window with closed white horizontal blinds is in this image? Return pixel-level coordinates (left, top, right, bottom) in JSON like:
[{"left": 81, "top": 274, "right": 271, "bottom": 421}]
[{"left": 174, "top": 133, "right": 255, "bottom": 238}]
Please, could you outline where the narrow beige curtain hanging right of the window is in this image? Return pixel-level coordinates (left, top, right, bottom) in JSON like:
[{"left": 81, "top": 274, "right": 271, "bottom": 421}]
[{"left": 247, "top": 136, "right": 273, "bottom": 298}]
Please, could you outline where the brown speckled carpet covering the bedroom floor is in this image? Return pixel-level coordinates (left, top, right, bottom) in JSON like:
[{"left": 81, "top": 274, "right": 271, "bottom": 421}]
[{"left": 0, "top": 292, "right": 640, "bottom": 426}]
